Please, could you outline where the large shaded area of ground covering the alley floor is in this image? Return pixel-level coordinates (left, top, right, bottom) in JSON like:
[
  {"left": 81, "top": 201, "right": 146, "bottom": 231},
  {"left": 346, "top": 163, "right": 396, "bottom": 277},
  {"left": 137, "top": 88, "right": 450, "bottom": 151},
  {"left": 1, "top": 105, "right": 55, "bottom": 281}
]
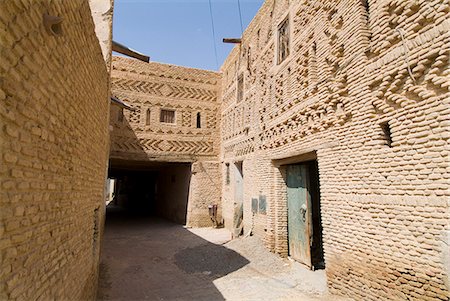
[{"left": 98, "top": 208, "right": 249, "bottom": 300}]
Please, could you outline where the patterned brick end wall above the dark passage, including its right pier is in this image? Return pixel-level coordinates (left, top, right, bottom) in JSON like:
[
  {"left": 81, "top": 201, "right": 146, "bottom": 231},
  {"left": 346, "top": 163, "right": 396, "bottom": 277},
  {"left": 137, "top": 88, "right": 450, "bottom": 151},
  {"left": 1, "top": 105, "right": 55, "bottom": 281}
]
[{"left": 110, "top": 57, "right": 221, "bottom": 227}]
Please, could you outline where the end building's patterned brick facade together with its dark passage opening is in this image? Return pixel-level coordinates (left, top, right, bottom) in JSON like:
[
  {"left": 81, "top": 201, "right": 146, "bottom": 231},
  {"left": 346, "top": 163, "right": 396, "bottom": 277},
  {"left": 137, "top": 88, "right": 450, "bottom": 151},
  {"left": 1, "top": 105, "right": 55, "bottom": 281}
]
[{"left": 110, "top": 57, "right": 221, "bottom": 226}]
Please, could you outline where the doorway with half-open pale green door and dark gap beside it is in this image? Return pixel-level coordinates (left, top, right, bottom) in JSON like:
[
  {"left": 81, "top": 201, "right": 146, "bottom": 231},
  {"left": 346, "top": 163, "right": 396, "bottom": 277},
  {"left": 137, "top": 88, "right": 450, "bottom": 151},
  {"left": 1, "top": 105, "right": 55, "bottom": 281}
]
[{"left": 286, "top": 160, "right": 325, "bottom": 270}]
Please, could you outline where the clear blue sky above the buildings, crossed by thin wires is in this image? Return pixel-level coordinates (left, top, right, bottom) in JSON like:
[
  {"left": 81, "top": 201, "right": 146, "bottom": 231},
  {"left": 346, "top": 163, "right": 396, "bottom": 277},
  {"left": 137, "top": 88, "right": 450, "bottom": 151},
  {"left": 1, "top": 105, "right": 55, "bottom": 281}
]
[{"left": 113, "top": 0, "right": 264, "bottom": 70}]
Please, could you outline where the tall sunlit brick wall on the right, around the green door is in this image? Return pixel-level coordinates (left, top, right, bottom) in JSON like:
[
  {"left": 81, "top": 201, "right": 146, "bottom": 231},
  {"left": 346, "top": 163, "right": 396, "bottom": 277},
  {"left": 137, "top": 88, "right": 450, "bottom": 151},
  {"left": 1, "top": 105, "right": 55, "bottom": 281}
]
[{"left": 221, "top": 0, "right": 450, "bottom": 300}]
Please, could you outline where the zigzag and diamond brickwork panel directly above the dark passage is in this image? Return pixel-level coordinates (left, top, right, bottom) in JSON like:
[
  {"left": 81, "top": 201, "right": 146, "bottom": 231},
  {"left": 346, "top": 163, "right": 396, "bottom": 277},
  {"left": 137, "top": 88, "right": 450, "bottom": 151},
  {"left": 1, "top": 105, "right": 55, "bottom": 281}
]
[{"left": 111, "top": 57, "right": 220, "bottom": 162}]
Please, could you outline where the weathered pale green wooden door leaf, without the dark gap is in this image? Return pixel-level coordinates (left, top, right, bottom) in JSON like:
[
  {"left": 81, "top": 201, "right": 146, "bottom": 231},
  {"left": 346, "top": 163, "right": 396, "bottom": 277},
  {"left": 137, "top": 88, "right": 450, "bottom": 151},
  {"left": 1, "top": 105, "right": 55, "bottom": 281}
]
[{"left": 286, "top": 164, "right": 312, "bottom": 267}]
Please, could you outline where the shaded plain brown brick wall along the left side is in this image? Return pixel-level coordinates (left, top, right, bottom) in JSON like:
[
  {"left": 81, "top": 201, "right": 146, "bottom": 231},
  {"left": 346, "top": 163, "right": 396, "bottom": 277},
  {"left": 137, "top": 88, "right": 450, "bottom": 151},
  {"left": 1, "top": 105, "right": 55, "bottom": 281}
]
[{"left": 0, "top": 0, "right": 110, "bottom": 300}]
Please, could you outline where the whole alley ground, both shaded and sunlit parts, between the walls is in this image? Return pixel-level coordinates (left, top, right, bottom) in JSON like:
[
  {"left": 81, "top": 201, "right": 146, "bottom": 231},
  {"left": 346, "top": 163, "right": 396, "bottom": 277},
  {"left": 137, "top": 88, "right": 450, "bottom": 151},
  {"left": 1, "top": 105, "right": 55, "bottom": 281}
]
[{"left": 98, "top": 208, "right": 352, "bottom": 300}]
